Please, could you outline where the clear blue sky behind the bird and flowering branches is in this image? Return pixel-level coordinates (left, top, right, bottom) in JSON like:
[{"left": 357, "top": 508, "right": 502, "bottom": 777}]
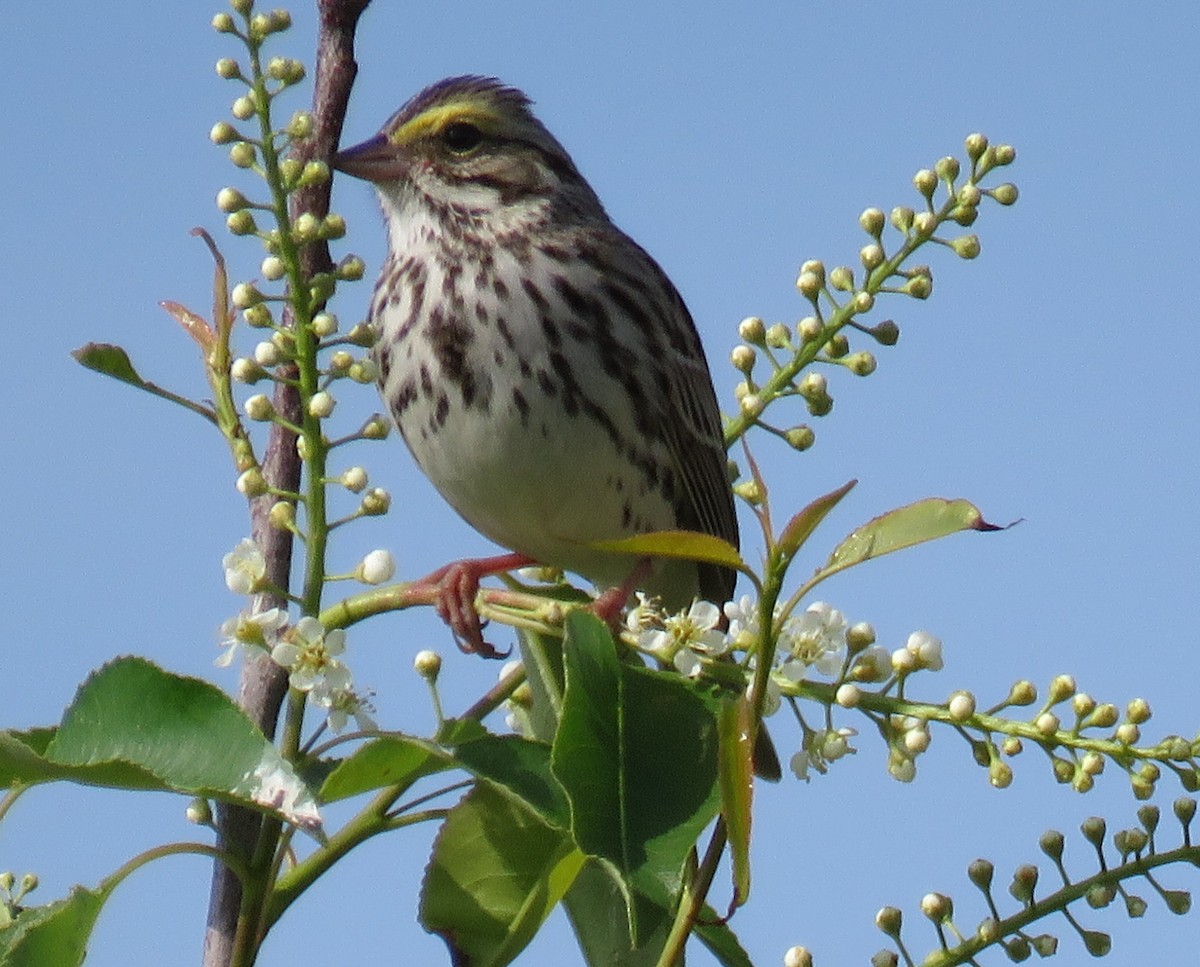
[{"left": 0, "top": 0, "right": 1200, "bottom": 967}]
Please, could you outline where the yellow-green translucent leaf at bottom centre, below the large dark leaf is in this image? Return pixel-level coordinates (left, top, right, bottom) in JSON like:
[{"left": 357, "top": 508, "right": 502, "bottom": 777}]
[{"left": 420, "top": 782, "right": 584, "bottom": 967}]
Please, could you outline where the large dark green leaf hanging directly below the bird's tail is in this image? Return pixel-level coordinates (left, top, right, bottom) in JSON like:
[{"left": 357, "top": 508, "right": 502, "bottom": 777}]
[{"left": 552, "top": 611, "right": 718, "bottom": 947}]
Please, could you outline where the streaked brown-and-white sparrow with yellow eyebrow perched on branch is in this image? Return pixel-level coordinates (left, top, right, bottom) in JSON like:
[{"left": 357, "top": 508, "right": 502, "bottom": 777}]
[{"left": 334, "top": 77, "right": 738, "bottom": 655}]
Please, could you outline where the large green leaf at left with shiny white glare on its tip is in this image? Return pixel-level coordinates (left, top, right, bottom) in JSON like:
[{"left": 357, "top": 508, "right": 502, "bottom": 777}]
[{"left": 10, "top": 657, "right": 320, "bottom": 829}]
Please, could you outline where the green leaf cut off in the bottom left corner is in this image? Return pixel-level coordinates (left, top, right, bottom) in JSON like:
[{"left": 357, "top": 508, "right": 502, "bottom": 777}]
[{"left": 0, "top": 885, "right": 112, "bottom": 967}]
